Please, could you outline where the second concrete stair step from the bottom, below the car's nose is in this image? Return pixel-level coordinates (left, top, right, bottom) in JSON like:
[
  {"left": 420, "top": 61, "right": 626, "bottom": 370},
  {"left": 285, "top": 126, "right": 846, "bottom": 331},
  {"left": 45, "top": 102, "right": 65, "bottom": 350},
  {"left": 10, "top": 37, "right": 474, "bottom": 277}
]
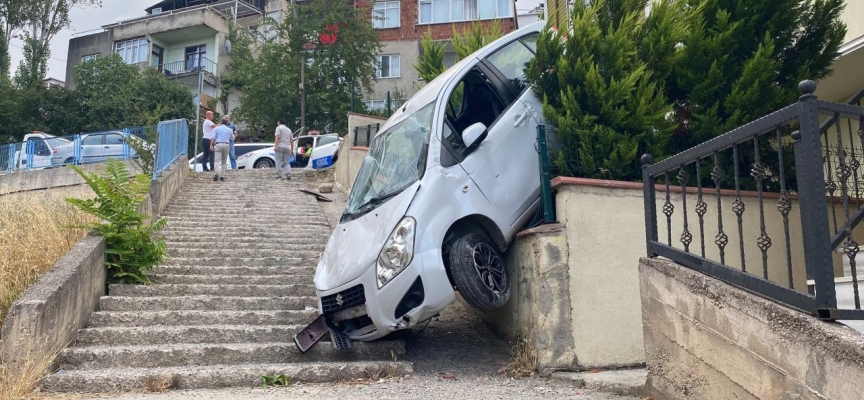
[{"left": 60, "top": 340, "right": 405, "bottom": 370}]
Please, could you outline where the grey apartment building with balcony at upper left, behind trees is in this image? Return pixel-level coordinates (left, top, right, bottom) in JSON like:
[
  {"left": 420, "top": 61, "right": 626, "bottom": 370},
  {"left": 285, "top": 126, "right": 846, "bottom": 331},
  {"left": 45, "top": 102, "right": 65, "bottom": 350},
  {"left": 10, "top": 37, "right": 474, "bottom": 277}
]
[{"left": 66, "top": 0, "right": 288, "bottom": 118}]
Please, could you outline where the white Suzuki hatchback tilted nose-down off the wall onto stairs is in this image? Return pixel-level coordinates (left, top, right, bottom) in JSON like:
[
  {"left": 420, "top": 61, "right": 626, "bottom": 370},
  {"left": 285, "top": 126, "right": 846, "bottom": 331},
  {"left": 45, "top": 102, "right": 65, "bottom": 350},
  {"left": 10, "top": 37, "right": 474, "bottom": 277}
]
[{"left": 295, "top": 22, "right": 544, "bottom": 351}]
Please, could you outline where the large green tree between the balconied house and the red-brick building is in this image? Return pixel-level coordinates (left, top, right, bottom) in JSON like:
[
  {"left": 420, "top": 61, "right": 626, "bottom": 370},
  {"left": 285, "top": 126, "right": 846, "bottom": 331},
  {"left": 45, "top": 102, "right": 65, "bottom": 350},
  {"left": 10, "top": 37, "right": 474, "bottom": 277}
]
[{"left": 222, "top": 0, "right": 381, "bottom": 132}]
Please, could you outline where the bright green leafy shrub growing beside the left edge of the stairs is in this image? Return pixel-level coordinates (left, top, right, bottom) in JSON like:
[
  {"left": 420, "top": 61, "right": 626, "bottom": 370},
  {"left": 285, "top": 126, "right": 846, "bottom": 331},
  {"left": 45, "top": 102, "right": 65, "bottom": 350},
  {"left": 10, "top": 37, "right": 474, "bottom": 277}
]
[{"left": 66, "top": 159, "right": 167, "bottom": 284}]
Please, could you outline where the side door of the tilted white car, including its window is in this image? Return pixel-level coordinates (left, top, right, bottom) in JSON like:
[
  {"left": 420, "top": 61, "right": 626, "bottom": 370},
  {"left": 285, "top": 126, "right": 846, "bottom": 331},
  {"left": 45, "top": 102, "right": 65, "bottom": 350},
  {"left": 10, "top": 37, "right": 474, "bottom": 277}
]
[{"left": 449, "top": 34, "right": 540, "bottom": 227}]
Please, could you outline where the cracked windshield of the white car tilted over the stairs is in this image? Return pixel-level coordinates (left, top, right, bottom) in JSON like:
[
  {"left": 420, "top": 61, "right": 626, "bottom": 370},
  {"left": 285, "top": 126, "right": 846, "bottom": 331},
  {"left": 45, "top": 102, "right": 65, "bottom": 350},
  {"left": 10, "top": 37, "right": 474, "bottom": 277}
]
[{"left": 342, "top": 103, "right": 435, "bottom": 221}]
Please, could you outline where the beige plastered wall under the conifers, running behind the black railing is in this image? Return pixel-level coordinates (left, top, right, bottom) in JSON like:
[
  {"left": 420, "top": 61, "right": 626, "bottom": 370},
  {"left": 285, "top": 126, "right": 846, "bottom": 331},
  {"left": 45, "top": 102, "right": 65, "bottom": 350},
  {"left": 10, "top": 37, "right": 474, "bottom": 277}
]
[{"left": 484, "top": 178, "right": 842, "bottom": 370}]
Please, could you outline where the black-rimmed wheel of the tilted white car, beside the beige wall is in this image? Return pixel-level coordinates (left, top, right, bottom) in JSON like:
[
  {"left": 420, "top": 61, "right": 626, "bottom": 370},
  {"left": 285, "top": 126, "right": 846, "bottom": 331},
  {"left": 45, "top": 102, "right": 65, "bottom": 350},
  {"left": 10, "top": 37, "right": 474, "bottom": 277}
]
[{"left": 449, "top": 233, "right": 510, "bottom": 310}]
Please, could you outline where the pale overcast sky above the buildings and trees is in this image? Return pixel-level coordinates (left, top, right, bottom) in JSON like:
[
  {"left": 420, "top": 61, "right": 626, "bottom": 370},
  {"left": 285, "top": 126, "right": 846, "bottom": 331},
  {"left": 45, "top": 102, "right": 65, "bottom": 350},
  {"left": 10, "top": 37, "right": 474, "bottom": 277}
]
[{"left": 9, "top": 0, "right": 543, "bottom": 81}]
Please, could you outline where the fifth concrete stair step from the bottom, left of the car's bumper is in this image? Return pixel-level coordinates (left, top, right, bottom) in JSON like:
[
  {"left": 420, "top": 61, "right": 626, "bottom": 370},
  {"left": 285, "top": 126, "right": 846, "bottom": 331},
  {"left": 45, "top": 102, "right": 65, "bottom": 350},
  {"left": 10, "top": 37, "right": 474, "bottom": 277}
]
[{"left": 99, "top": 296, "right": 318, "bottom": 311}]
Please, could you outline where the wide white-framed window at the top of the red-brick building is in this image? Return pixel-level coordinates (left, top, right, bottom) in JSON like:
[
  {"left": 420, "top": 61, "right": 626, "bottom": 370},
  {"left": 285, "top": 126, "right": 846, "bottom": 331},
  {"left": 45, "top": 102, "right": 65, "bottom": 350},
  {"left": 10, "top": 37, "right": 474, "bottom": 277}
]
[{"left": 418, "top": 0, "right": 512, "bottom": 24}]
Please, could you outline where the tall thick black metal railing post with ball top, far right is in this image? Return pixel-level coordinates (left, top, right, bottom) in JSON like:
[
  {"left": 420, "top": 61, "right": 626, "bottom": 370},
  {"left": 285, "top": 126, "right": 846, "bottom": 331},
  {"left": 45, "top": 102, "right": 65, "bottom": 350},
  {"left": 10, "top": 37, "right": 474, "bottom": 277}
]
[{"left": 793, "top": 80, "right": 837, "bottom": 319}]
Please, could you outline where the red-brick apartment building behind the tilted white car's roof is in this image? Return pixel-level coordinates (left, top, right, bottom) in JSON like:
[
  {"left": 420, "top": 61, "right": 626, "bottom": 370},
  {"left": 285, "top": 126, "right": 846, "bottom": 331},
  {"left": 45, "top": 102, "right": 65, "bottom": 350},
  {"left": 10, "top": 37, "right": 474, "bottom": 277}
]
[{"left": 354, "top": 0, "right": 516, "bottom": 109}]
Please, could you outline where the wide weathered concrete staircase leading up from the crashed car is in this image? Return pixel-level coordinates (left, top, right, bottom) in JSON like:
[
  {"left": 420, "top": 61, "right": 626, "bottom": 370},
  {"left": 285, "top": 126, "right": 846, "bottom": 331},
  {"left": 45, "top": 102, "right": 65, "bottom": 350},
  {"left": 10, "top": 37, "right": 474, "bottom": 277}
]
[{"left": 42, "top": 170, "right": 412, "bottom": 393}]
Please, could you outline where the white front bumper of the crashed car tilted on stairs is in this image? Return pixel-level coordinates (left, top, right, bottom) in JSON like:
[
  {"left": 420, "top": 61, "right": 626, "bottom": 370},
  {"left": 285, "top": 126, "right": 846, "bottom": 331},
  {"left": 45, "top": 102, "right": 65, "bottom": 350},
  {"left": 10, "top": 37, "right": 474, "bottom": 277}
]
[{"left": 316, "top": 249, "right": 456, "bottom": 341}]
